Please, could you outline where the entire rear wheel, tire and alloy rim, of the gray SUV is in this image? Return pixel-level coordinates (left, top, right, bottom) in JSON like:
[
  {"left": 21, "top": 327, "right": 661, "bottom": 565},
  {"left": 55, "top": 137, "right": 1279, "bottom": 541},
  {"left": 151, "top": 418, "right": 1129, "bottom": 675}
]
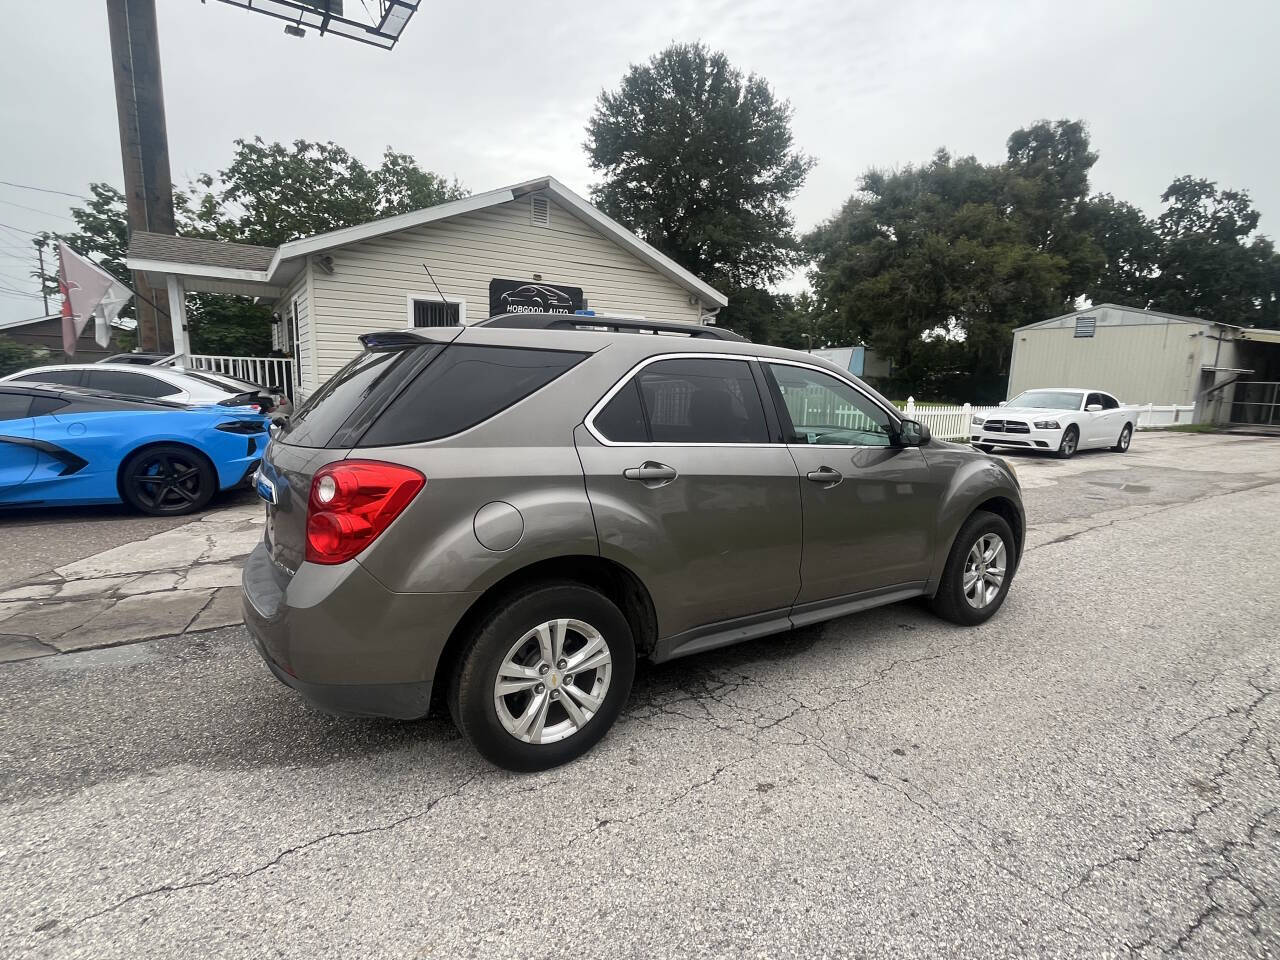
[{"left": 449, "top": 582, "right": 636, "bottom": 771}]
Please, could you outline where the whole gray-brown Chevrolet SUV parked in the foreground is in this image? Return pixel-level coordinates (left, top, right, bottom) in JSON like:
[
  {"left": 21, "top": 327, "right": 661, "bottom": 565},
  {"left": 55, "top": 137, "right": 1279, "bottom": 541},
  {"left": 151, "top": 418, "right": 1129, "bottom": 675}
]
[{"left": 243, "top": 314, "right": 1024, "bottom": 771}]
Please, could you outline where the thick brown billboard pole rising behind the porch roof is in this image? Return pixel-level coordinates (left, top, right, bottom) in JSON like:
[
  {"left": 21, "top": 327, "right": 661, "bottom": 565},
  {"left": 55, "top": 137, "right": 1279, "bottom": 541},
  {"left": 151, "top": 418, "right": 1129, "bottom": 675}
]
[{"left": 106, "top": 0, "right": 174, "bottom": 352}]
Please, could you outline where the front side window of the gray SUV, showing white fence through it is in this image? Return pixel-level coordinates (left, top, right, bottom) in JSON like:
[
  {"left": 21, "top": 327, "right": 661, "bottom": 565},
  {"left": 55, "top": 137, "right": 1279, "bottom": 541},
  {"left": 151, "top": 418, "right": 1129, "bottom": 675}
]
[{"left": 769, "top": 364, "right": 893, "bottom": 447}]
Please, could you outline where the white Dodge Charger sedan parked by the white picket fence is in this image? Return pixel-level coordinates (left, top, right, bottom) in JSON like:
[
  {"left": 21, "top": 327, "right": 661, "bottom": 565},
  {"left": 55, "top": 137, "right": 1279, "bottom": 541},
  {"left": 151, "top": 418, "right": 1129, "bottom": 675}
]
[{"left": 970, "top": 388, "right": 1138, "bottom": 457}]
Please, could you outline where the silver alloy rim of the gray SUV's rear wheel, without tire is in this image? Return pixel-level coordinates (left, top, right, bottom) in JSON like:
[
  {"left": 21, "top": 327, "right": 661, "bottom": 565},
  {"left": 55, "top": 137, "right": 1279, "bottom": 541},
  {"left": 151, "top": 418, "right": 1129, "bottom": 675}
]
[{"left": 493, "top": 618, "right": 613, "bottom": 744}]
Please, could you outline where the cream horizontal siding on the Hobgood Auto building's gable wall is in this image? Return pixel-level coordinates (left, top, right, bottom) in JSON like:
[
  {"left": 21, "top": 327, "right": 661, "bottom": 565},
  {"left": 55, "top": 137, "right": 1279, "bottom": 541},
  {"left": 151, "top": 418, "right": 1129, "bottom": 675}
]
[{"left": 303, "top": 196, "right": 701, "bottom": 385}]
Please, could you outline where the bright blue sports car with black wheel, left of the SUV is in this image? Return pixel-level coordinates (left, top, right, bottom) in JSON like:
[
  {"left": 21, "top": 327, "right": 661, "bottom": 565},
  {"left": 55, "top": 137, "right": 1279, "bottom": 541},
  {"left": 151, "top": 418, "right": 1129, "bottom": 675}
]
[{"left": 0, "top": 383, "right": 269, "bottom": 516}]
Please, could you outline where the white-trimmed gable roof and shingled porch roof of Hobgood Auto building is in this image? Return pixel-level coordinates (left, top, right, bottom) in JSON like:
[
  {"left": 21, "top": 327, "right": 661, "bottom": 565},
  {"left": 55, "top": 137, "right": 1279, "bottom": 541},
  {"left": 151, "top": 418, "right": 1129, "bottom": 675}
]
[{"left": 128, "top": 177, "right": 728, "bottom": 307}]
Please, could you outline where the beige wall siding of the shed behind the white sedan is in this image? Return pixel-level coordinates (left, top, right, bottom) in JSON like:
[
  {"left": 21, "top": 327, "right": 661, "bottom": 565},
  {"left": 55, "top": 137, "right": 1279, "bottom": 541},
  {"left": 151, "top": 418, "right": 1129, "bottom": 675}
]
[{"left": 1009, "top": 308, "right": 1217, "bottom": 403}]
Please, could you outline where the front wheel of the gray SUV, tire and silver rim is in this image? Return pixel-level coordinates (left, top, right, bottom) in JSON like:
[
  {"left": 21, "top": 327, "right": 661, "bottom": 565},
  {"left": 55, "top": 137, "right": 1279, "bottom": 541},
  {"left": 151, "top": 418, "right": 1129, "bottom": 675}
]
[{"left": 929, "top": 509, "right": 1018, "bottom": 626}]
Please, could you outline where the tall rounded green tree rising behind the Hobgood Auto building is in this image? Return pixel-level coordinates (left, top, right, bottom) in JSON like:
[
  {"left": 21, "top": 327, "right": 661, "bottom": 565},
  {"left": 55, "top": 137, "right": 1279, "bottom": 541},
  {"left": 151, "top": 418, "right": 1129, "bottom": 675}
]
[{"left": 585, "top": 44, "right": 814, "bottom": 329}]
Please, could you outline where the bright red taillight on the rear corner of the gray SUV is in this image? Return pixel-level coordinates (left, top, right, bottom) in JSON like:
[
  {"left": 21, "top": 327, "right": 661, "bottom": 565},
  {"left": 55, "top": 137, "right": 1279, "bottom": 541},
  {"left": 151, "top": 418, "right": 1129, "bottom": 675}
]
[{"left": 306, "top": 460, "right": 426, "bottom": 563}]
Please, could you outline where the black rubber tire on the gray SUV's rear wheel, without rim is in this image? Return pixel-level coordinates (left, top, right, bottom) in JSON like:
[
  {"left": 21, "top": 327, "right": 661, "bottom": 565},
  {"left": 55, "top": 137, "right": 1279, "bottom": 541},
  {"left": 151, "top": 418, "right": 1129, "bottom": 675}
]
[{"left": 448, "top": 581, "right": 636, "bottom": 772}]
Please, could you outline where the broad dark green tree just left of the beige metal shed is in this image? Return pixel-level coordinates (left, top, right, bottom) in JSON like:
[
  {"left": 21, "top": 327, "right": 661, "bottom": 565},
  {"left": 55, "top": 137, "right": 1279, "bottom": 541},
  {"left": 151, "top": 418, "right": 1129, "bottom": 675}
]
[{"left": 808, "top": 135, "right": 1075, "bottom": 401}]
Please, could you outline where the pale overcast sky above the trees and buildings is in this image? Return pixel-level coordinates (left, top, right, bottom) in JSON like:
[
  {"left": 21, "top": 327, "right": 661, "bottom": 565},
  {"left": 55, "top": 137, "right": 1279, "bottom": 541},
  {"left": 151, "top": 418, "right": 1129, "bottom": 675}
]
[{"left": 0, "top": 0, "right": 1280, "bottom": 320}]
